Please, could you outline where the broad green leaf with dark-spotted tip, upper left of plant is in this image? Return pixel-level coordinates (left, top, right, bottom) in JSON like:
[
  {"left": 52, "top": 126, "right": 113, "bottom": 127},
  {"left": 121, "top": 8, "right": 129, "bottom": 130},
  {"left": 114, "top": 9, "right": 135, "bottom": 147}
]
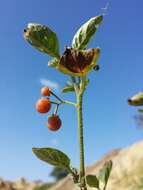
[{"left": 24, "top": 23, "right": 60, "bottom": 58}]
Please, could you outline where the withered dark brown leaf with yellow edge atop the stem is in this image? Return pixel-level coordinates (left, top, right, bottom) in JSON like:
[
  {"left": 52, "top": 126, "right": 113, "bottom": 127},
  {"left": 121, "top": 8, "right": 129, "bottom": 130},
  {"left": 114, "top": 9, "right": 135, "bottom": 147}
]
[{"left": 56, "top": 47, "right": 100, "bottom": 77}]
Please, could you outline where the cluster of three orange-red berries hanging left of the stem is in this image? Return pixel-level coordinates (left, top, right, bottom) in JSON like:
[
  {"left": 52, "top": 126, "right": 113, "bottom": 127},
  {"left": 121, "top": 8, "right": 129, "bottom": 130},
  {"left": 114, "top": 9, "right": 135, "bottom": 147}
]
[{"left": 36, "top": 87, "right": 62, "bottom": 131}]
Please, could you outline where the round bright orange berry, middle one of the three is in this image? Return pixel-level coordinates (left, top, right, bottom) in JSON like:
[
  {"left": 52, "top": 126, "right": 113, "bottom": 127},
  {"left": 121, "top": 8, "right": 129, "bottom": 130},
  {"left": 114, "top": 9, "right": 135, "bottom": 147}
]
[{"left": 36, "top": 99, "right": 51, "bottom": 113}]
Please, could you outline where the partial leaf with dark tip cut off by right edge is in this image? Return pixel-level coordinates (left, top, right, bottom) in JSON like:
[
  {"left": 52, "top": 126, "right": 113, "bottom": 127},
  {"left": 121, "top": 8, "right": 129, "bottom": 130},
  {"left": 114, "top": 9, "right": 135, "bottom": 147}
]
[{"left": 128, "top": 92, "right": 143, "bottom": 106}]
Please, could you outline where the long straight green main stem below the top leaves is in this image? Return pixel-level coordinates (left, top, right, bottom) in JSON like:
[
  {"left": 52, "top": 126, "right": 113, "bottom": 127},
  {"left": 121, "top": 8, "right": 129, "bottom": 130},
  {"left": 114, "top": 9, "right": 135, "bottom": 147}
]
[{"left": 77, "top": 91, "right": 87, "bottom": 190}]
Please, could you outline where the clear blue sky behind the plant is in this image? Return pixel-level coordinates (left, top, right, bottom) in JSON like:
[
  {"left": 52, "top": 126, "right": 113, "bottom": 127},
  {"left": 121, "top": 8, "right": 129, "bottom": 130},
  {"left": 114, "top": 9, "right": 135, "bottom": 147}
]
[{"left": 0, "top": 0, "right": 143, "bottom": 181}]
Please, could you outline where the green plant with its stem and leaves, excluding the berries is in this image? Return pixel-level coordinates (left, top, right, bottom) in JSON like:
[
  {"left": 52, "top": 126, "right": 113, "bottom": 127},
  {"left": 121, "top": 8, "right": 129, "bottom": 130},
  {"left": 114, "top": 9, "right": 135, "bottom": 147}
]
[{"left": 24, "top": 15, "right": 112, "bottom": 190}]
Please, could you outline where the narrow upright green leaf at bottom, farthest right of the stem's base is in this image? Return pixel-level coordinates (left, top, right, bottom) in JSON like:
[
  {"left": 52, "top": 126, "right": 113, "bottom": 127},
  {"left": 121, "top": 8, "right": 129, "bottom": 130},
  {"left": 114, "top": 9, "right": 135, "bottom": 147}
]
[{"left": 98, "top": 160, "right": 112, "bottom": 190}]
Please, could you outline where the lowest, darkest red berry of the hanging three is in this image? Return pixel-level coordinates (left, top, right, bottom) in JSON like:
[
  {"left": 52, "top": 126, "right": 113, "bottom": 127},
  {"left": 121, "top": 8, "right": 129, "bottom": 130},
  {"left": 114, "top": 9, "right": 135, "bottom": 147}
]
[{"left": 47, "top": 114, "right": 62, "bottom": 131}]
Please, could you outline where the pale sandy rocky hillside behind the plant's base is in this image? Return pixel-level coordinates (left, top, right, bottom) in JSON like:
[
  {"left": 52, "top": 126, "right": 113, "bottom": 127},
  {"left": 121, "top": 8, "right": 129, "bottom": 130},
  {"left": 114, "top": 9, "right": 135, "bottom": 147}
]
[{"left": 0, "top": 141, "right": 143, "bottom": 190}]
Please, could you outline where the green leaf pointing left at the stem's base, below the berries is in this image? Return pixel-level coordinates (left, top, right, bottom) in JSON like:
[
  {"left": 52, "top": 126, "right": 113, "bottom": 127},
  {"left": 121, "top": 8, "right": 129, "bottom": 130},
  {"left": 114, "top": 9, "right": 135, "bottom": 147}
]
[{"left": 32, "top": 148, "right": 70, "bottom": 170}]
